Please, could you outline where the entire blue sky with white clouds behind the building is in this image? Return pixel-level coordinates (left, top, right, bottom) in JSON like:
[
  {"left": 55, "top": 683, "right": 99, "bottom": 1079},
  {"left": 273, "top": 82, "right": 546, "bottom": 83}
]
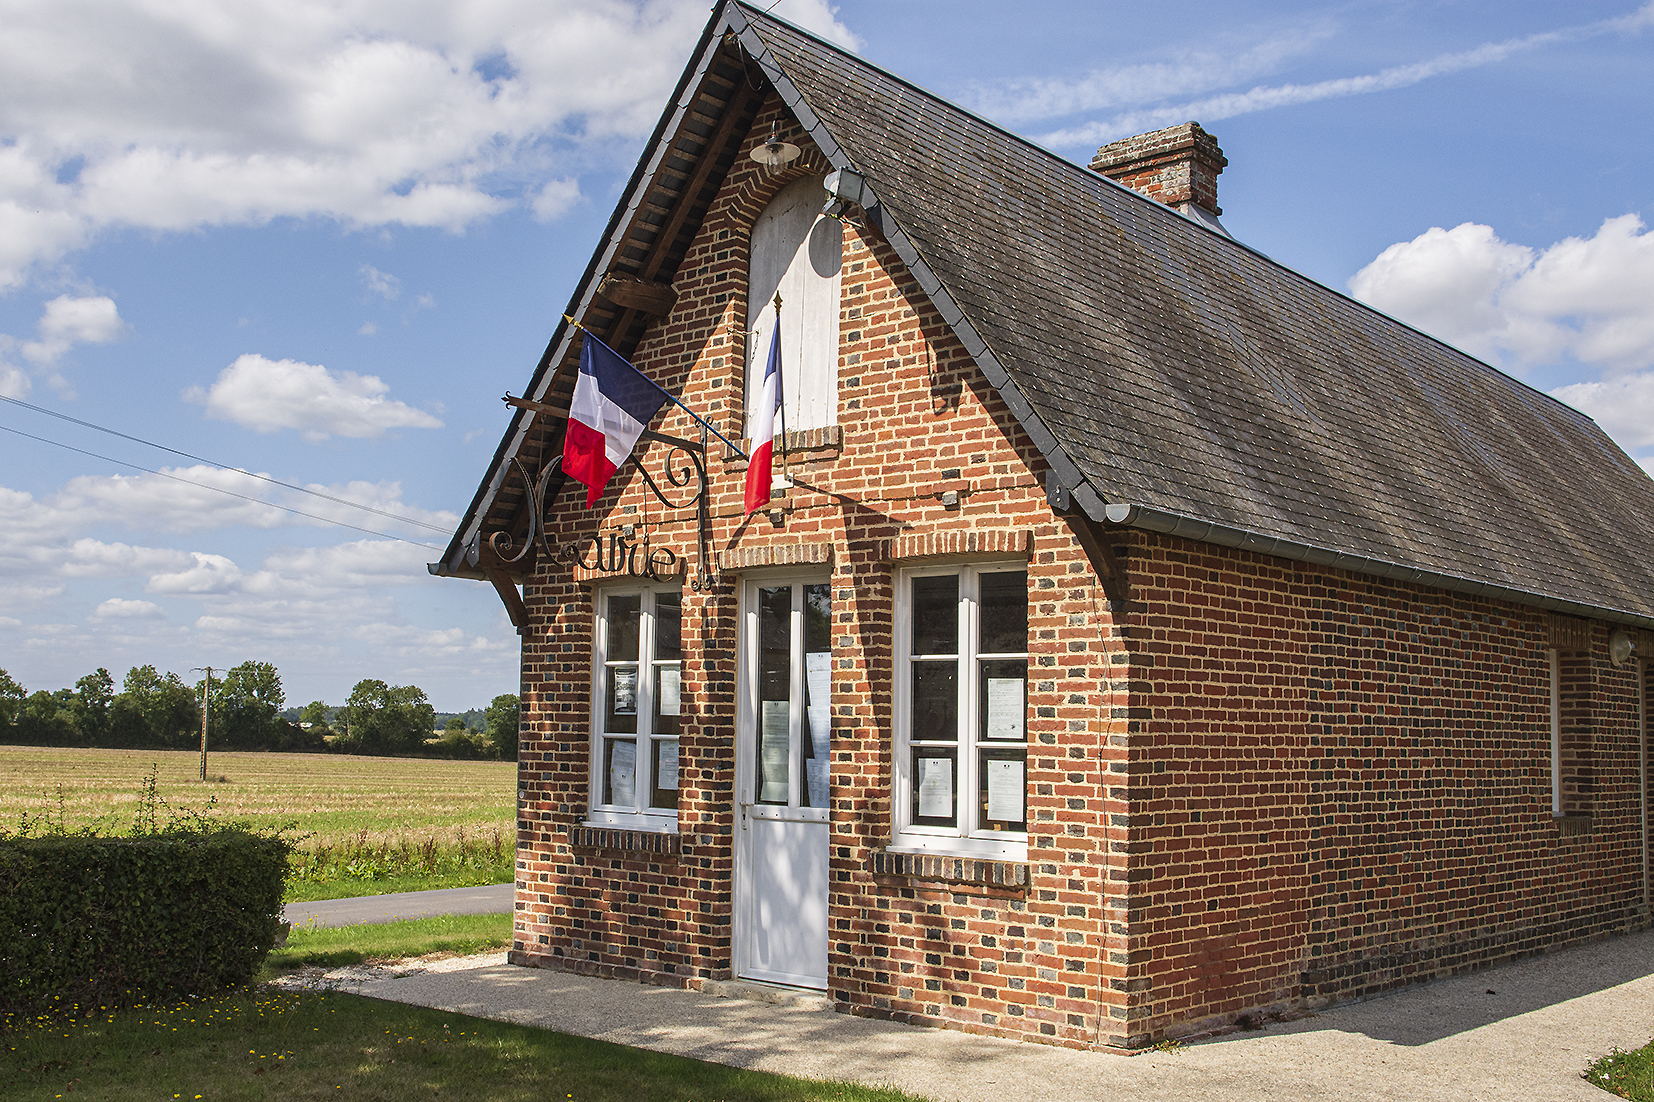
[{"left": 0, "top": 0, "right": 1654, "bottom": 710}]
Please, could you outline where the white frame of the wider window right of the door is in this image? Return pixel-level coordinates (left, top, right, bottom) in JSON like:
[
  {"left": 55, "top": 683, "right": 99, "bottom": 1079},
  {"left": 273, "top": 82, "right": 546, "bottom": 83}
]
[{"left": 890, "top": 559, "right": 1034, "bottom": 860}]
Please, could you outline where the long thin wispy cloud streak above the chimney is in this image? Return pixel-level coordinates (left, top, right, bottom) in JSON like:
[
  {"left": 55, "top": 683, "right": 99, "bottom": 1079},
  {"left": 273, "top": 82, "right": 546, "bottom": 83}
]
[{"left": 1030, "top": 3, "right": 1654, "bottom": 149}]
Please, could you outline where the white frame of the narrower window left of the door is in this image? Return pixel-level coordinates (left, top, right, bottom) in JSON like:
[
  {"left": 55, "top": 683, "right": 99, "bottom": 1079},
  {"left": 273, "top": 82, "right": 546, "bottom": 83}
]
[{"left": 587, "top": 584, "right": 683, "bottom": 834}]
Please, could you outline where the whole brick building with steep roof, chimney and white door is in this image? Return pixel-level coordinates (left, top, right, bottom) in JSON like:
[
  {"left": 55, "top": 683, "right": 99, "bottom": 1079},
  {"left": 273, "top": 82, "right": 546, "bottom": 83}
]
[{"left": 432, "top": 2, "right": 1654, "bottom": 1047}]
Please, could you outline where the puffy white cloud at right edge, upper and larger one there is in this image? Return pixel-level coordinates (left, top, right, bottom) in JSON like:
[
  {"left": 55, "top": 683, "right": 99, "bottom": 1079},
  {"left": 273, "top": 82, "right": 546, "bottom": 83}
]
[{"left": 1350, "top": 215, "right": 1654, "bottom": 374}]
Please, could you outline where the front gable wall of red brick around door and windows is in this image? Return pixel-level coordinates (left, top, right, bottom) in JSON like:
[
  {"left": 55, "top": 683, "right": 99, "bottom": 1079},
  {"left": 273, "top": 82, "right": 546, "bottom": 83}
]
[{"left": 514, "top": 92, "right": 1125, "bottom": 1044}]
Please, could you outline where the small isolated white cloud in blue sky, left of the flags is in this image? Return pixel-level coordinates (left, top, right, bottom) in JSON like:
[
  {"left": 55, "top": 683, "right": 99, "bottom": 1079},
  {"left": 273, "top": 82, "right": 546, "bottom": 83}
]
[{"left": 184, "top": 352, "right": 442, "bottom": 443}]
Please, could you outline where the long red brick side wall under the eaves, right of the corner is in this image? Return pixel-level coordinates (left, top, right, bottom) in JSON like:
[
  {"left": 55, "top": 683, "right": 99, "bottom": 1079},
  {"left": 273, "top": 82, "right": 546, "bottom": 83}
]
[{"left": 1123, "top": 533, "right": 1647, "bottom": 1042}]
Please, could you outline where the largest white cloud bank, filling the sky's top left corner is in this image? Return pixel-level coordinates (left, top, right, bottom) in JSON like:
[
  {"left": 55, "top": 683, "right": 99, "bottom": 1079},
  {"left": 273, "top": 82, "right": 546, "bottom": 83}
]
[{"left": 0, "top": 0, "right": 740, "bottom": 290}]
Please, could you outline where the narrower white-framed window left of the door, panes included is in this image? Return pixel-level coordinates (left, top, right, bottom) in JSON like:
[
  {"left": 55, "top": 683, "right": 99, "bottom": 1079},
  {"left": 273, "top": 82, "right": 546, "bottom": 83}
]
[{"left": 592, "top": 587, "right": 683, "bottom": 831}]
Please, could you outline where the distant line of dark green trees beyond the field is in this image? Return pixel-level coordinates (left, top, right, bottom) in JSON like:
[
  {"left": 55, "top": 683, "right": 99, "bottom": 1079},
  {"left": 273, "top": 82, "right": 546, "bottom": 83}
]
[{"left": 0, "top": 662, "right": 518, "bottom": 761}]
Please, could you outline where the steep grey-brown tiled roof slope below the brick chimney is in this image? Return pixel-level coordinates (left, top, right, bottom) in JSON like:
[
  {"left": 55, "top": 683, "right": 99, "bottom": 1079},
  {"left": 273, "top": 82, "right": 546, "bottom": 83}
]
[{"left": 744, "top": 5, "right": 1654, "bottom": 624}]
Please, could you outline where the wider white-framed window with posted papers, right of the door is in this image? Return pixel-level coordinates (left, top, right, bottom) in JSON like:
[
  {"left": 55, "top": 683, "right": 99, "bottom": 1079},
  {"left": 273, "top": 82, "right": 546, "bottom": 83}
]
[{"left": 895, "top": 563, "right": 1029, "bottom": 860}]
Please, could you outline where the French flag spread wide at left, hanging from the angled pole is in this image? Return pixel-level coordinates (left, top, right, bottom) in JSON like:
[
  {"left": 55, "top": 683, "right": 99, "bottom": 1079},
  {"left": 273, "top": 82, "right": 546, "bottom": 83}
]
[{"left": 562, "top": 333, "right": 668, "bottom": 508}]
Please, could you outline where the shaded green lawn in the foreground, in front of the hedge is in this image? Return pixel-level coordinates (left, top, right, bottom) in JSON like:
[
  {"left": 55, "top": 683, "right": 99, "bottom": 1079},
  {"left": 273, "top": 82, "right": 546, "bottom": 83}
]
[{"left": 0, "top": 988, "right": 932, "bottom": 1102}]
